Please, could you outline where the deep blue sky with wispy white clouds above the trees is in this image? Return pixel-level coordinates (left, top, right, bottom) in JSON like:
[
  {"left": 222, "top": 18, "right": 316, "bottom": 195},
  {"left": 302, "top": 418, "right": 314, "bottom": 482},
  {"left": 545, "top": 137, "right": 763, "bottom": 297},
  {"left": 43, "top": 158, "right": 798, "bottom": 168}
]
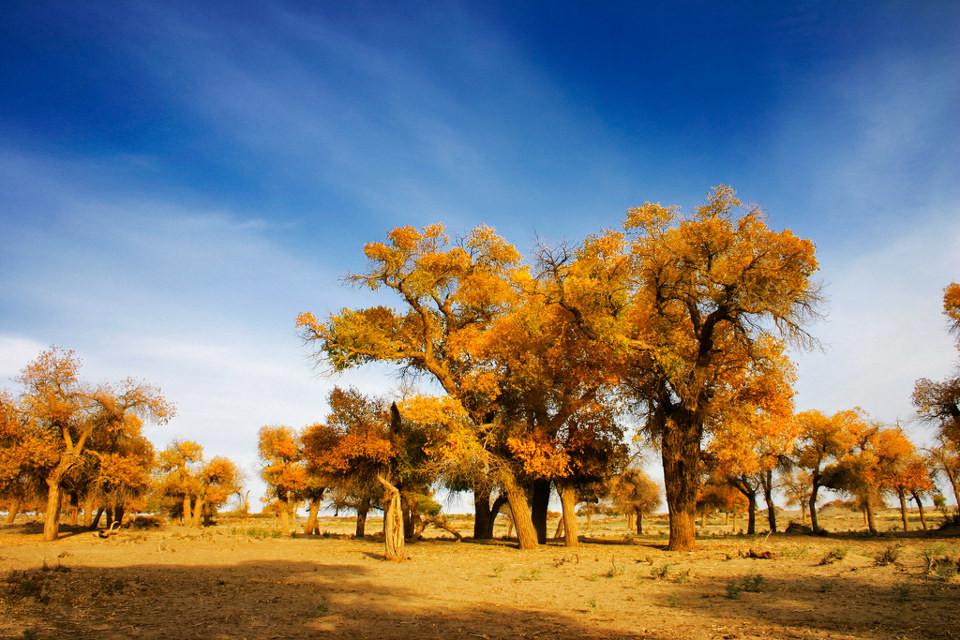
[{"left": 0, "top": 2, "right": 960, "bottom": 510}]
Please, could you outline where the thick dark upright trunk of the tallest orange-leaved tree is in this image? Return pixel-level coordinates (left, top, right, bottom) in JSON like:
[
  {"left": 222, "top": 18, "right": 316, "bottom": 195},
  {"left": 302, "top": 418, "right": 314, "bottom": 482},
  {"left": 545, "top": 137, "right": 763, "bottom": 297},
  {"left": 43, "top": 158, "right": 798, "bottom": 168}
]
[{"left": 660, "top": 421, "right": 700, "bottom": 551}]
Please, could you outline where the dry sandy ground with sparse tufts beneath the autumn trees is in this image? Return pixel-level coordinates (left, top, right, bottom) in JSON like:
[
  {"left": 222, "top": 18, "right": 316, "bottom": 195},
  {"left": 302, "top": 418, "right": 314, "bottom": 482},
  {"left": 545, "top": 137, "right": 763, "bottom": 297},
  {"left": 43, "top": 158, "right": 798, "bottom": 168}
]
[{"left": 0, "top": 516, "right": 960, "bottom": 639}]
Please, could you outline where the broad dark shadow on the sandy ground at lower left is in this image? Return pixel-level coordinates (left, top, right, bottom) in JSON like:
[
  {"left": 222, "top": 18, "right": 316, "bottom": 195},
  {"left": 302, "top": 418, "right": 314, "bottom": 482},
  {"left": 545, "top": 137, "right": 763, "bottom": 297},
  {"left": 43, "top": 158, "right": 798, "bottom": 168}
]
[{"left": 0, "top": 561, "right": 651, "bottom": 640}]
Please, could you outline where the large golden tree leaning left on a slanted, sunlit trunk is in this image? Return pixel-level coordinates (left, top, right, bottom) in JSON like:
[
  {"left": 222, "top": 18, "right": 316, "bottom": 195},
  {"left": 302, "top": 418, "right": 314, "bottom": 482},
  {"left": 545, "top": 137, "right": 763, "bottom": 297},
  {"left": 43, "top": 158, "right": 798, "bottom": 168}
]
[{"left": 297, "top": 225, "right": 537, "bottom": 548}]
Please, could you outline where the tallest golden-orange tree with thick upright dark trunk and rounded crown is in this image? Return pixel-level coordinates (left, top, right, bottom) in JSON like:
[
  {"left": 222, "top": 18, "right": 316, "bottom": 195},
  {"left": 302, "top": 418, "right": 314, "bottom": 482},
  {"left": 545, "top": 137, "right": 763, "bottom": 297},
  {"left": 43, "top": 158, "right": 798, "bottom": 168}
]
[{"left": 553, "top": 187, "right": 818, "bottom": 550}]
